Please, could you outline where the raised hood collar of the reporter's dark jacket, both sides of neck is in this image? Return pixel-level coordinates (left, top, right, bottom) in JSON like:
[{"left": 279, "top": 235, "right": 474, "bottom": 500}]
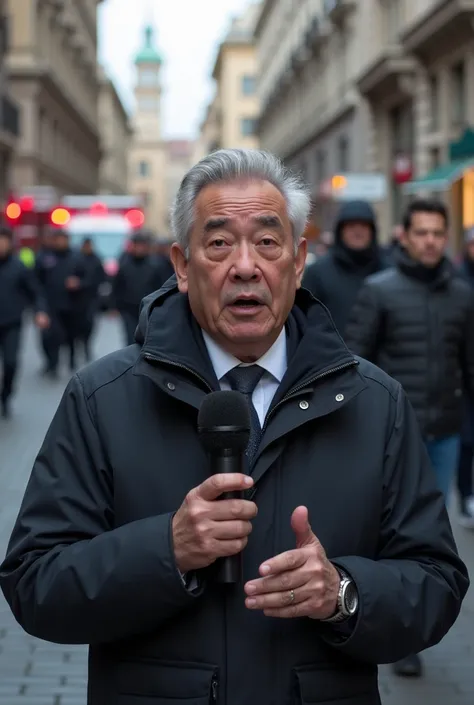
[{"left": 135, "top": 275, "right": 357, "bottom": 396}]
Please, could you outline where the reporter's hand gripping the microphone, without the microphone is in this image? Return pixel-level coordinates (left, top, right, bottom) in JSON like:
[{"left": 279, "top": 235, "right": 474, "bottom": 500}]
[{"left": 173, "top": 473, "right": 257, "bottom": 573}]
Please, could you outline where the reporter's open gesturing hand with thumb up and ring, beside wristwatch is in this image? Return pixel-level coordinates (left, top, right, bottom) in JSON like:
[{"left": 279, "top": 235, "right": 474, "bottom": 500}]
[{"left": 245, "top": 507, "right": 340, "bottom": 619}]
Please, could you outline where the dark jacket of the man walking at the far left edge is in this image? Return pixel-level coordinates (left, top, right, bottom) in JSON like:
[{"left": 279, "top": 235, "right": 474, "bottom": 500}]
[{"left": 0, "top": 255, "right": 46, "bottom": 328}]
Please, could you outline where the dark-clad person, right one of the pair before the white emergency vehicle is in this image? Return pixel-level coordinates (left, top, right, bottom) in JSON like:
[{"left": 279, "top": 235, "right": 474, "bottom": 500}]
[{"left": 79, "top": 237, "right": 105, "bottom": 362}]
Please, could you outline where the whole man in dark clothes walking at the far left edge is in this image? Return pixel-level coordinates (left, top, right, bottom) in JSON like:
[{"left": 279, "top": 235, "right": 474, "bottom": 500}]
[{"left": 0, "top": 225, "right": 49, "bottom": 418}]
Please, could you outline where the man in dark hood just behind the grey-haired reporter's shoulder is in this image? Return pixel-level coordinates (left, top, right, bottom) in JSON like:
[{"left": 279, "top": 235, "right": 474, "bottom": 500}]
[{"left": 303, "top": 201, "right": 389, "bottom": 335}]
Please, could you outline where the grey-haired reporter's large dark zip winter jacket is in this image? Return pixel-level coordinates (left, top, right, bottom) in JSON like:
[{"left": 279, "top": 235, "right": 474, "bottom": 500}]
[{"left": 0, "top": 279, "right": 468, "bottom": 705}]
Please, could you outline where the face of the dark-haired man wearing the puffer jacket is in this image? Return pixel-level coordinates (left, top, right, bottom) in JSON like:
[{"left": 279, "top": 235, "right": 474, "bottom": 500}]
[{"left": 402, "top": 212, "right": 448, "bottom": 267}]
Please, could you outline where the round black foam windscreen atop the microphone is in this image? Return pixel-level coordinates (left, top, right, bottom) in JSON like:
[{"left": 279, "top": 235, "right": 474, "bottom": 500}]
[{"left": 198, "top": 391, "right": 250, "bottom": 452}]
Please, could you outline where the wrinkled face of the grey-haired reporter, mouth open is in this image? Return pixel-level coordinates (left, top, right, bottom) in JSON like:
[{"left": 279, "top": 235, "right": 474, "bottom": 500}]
[{"left": 171, "top": 181, "right": 306, "bottom": 362}]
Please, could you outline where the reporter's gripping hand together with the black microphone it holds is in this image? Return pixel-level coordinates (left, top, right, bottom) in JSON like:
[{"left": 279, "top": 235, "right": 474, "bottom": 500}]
[{"left": 173, "top": 392, "right": 257, "bottom": 583}]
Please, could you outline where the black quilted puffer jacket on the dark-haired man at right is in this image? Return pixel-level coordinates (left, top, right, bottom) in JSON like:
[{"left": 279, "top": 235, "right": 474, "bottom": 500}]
[{"left": 346, "top": 250, "right": 474, "bottom": 439}]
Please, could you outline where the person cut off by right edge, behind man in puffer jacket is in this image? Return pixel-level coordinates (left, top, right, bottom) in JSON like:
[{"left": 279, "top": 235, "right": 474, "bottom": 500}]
[{"left": 457, "top": 228, "right": 474, "bottom": 529}]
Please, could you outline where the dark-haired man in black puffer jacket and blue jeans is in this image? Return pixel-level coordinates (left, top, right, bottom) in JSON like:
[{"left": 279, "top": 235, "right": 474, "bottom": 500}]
[{"left": 346, "top": 200, "right": 474, "bottom": 676}]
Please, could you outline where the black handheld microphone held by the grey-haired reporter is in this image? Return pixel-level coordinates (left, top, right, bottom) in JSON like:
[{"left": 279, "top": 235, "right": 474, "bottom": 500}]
[{"left": 198, "top": 391, "right": 250, "bottom": 584}]
